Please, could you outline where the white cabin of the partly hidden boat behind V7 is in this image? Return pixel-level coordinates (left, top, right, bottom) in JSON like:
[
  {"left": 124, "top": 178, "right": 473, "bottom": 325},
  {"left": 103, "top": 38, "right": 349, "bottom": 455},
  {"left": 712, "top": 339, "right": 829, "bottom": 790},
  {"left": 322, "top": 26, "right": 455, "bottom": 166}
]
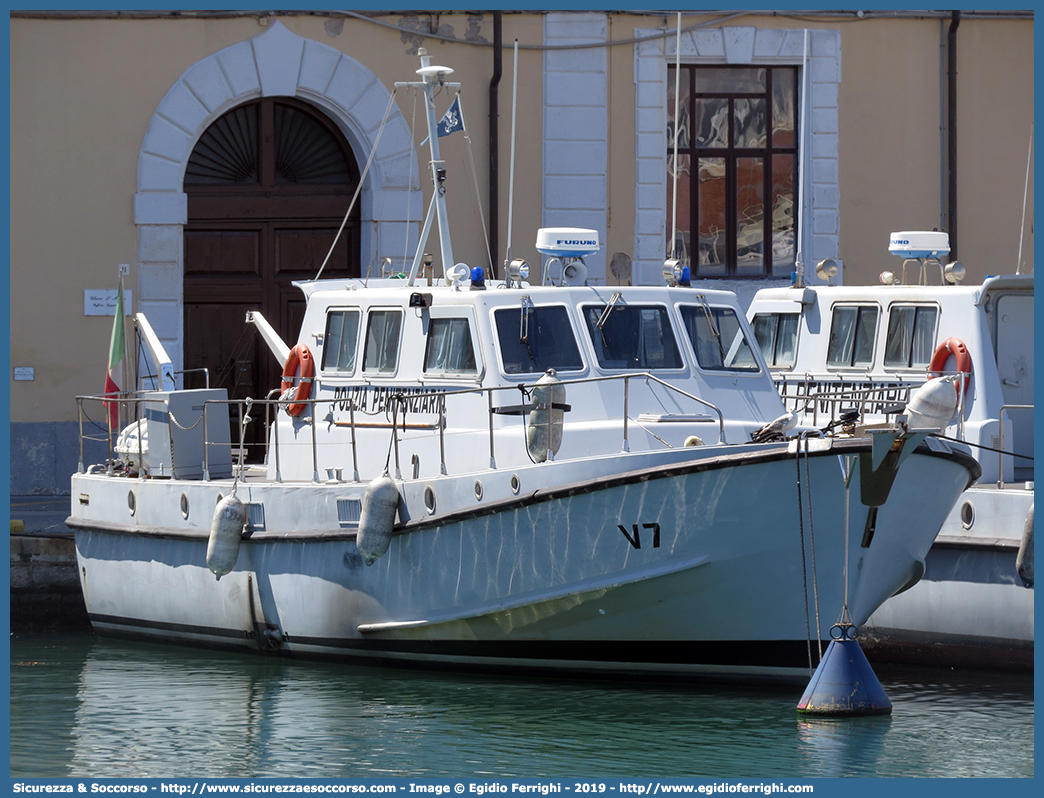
[{"left": 748, "top": 267, "right": 1034, "bottom": 482}]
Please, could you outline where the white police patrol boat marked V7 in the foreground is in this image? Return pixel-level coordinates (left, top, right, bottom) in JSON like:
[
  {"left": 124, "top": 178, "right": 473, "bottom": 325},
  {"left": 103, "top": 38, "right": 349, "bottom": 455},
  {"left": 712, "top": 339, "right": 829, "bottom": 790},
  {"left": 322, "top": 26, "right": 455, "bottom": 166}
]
[{"left": 68, "top": 55, "right": 979, "bottom": 682}]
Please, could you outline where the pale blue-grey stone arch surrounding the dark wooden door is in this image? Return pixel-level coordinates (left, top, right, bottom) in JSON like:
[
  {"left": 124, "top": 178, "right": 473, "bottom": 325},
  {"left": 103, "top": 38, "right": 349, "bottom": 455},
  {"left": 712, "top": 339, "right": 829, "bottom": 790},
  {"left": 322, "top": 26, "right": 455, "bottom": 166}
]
[{"left": 134, "top": 21, "right": 423, "bottom": 378}]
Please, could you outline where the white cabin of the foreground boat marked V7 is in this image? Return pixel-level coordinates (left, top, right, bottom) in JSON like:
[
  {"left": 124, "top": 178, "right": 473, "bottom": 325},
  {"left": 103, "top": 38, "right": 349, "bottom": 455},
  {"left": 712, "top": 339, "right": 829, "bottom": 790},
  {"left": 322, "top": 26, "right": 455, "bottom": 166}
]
[{"left": 261, "top": 275, "right": 783, "bottom": 486}]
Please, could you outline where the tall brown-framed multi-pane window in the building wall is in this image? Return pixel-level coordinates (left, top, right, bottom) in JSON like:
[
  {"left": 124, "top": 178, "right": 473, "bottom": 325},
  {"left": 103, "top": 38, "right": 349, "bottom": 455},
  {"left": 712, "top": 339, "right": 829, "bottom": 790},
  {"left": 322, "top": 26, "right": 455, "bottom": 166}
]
[{"left": 666, "top": 65, "right": 798, "bottom": 278}]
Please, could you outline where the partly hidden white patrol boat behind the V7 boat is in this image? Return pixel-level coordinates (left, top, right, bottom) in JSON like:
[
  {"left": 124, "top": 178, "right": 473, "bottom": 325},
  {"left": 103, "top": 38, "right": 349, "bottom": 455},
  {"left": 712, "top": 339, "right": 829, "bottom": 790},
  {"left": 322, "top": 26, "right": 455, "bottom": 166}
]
[{"left": 748, "top": 231, "right": 1034, "bottom": 668}]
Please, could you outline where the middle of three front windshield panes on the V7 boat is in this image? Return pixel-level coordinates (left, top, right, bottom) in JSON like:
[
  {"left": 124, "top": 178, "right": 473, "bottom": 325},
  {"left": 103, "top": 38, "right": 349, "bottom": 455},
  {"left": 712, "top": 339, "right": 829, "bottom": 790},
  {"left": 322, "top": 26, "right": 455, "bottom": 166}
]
[{"left": 584, "top": 304, "right": 683, "bottom": 370}]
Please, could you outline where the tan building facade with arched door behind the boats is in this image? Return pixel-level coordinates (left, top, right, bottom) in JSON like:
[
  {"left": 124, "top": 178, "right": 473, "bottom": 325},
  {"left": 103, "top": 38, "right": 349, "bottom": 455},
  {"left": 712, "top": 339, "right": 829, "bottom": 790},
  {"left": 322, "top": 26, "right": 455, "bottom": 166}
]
[{"left": 9, "top": 10, "right": 1034, "bottom": 494}]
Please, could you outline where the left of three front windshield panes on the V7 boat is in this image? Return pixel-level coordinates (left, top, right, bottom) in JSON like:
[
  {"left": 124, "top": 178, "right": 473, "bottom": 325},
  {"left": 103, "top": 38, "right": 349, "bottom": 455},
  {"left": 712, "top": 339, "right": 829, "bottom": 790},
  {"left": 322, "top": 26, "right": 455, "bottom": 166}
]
[{"left": 494, "top": 304, "right": 584, "bottom": 374}]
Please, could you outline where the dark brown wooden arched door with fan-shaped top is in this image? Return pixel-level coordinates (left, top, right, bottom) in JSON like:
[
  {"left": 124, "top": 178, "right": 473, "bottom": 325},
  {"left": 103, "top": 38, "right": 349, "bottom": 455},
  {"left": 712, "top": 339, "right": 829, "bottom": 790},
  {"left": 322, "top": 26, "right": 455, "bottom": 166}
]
[{"left": 184, "top": 97, "right": 360, "bottom": 451}]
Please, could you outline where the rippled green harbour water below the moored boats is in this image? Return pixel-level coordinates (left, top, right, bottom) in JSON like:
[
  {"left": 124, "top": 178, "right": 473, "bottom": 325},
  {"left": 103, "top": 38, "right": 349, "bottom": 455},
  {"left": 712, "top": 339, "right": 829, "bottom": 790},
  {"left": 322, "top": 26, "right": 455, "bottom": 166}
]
[{"left": 10, "top": 632, "right": 1035, "bottom": 779}]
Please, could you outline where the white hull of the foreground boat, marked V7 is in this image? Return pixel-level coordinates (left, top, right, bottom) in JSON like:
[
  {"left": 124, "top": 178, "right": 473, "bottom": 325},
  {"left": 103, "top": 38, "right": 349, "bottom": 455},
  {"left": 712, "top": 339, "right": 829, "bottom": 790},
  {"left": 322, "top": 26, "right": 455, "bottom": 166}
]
[{"left": 69, "top": 442, "right": 974, "bottom": 681}]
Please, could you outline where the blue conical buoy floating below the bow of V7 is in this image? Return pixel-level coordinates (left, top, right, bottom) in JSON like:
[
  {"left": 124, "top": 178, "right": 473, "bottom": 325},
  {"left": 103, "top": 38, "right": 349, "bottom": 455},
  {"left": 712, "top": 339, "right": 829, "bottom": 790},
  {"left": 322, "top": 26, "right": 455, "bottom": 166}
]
[{"left": 798, "top": 639, "right": 892, "bottom": 715}]
